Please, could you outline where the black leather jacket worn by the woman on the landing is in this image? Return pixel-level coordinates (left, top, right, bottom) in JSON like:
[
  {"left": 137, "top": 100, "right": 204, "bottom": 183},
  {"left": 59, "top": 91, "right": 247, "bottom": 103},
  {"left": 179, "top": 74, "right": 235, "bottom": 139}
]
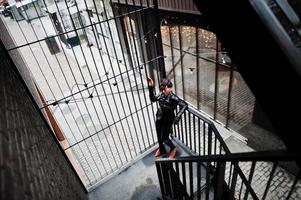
[{"left": 149, "top": 87, "right": 188, "bottom": 122}]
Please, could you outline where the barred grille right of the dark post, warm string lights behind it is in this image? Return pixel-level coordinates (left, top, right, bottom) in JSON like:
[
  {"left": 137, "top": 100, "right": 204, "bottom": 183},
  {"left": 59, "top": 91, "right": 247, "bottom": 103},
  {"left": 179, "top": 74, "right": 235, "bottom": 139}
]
[{"left": 161, "top": 23, "right": 255, "bottom": 131}]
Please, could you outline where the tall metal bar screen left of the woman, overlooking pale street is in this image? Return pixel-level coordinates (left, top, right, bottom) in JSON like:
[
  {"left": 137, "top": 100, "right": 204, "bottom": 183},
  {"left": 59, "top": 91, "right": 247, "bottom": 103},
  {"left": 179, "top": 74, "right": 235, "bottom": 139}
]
[{"left": 1, "top": 0, "right": 157, "bottom": 190}]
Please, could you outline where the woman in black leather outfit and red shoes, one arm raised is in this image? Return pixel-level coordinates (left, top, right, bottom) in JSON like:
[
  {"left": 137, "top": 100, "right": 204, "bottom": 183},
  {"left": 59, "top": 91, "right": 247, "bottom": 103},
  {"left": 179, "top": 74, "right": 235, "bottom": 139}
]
[{"left": 147, "top": 78, "right": 188, "bottom": 158}]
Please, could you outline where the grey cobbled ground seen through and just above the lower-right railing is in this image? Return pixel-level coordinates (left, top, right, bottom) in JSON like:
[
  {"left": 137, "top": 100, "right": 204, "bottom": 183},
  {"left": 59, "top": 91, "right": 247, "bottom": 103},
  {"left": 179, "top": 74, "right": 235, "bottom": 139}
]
[{"left": 225, "top": 136, "right": 301, "bottom": 200}]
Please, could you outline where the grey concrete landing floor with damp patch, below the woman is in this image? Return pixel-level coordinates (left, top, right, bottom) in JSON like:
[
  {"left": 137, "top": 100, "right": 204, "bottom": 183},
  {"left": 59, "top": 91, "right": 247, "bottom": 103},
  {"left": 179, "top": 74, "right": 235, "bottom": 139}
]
[{"left": 88, "top": 143, "right": 192, "bottom": 200}]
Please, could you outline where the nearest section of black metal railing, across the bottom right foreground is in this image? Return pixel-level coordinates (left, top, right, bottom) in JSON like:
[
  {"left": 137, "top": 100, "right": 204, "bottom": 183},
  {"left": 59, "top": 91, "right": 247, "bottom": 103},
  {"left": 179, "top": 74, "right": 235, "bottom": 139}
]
[{"left": 156, "top": 151, "right": 301, "bottom": 199}]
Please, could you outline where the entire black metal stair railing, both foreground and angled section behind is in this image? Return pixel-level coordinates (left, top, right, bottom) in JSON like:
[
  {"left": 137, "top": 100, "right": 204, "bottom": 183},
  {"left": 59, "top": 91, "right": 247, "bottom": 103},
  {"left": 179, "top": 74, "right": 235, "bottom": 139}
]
[{"left": 156, "top": 108, "right": 301, "bottom": 200}]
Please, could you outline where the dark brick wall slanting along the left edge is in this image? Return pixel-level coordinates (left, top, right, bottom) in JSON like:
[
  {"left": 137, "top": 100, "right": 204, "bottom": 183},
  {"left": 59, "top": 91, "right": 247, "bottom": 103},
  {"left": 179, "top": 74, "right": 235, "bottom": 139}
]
[{"left": 0, "top": 41, "right": 87, "bottom": 200}]
